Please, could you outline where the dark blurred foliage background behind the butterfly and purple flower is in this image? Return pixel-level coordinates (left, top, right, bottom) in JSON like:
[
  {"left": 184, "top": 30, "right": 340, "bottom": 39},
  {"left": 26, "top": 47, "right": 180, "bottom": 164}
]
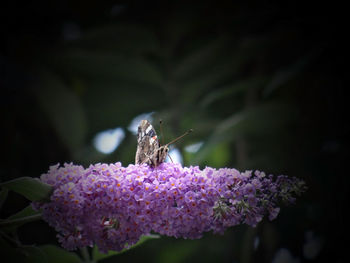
[{"left": 0, "top": 1, "right": 349, "bottom": 263}]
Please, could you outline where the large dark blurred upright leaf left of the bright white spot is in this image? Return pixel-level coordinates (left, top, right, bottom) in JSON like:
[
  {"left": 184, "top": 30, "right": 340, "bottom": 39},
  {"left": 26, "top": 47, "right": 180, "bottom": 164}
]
[{"left": 35, "top": 72, "right": 87, "bottom": 155}]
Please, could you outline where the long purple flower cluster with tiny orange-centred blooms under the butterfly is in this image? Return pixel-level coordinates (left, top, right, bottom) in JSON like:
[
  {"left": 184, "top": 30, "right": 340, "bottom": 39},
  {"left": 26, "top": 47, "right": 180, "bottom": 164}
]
[{"left": 34, "top": 163, "right": 304, "bottom": 252}]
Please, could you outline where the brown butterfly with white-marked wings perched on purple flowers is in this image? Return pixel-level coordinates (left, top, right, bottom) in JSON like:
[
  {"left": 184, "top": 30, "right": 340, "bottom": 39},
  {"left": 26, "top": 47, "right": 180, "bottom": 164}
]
[{"left": 135, "top": 120, "right": 193, "bottom": 167}]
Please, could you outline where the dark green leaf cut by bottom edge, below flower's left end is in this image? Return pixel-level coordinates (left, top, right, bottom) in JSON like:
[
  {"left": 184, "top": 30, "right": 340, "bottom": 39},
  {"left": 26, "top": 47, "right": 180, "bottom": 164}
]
[{"left": 40, "top": 245, "right": 81, "bottom": 263}]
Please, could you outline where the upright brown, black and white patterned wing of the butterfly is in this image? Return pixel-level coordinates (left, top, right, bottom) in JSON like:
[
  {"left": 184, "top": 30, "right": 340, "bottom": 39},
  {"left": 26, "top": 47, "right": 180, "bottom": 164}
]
[{"left": 135, "top": 120, "right": 159, "bottom": 165}]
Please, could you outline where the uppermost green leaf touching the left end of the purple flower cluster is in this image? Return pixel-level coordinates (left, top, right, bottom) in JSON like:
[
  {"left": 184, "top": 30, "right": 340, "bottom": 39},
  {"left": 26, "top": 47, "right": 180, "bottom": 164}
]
[{"left": 0, "top": 177, "right": 53, "bottom": 201}]
